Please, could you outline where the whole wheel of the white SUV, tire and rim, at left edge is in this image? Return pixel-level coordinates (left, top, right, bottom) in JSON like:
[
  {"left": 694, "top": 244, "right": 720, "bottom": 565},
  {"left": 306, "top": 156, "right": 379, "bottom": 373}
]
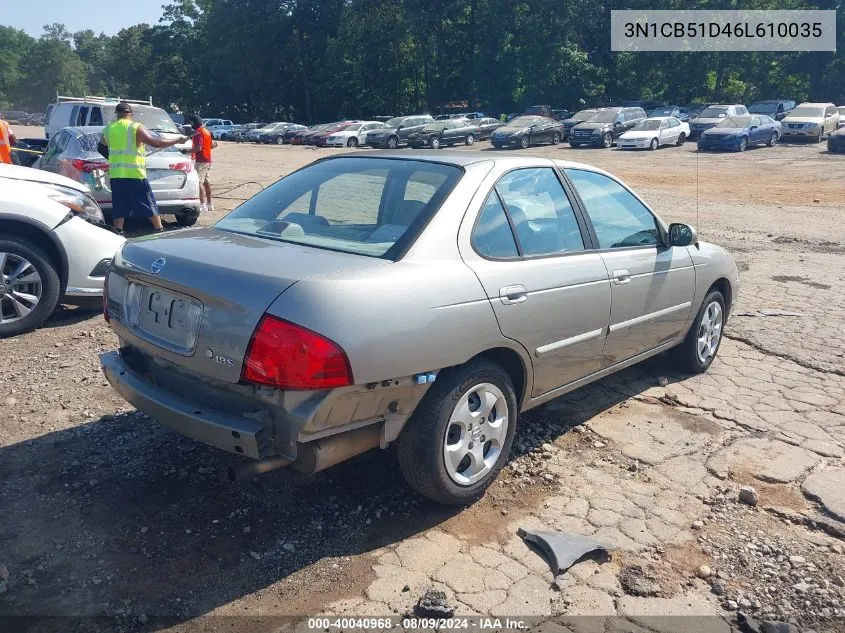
[{"left": 0, "top": 235, "right": 61, "bottom": 338}]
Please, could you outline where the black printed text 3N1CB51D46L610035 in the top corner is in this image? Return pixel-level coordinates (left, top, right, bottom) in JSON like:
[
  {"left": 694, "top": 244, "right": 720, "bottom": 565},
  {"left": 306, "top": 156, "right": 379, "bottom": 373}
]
[{"left": 624, "top": 22, "right": 822, "bottom": 39}]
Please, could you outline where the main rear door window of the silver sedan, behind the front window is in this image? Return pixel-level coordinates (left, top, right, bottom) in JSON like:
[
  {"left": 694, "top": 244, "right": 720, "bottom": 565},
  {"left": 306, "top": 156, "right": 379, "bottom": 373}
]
[{"left": 496, "top": 167, "right": 584, "bottom": 255}]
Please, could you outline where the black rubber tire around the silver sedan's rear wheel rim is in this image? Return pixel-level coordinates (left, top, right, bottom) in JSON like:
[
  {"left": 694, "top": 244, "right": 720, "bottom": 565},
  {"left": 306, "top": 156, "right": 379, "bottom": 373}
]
[{"left": 396, "top": 361, "right": 518, "bottom": 505}]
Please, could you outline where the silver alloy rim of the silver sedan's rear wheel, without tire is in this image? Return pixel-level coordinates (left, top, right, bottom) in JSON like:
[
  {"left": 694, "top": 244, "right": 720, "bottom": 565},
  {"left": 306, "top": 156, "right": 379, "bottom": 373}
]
[{"left": 443, "top": 382, "right": 510, "bottom": 486}]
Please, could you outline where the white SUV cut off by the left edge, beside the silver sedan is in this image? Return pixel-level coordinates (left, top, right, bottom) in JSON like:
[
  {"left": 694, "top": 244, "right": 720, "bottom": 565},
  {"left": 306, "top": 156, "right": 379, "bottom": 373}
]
[{"left": 0, "top": 164, "right": 125, "bottom": 338}]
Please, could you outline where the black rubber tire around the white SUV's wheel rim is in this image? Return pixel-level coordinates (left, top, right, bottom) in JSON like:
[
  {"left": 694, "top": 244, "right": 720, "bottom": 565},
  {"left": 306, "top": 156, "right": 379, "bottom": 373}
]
[{"left": 0, "top": 234, "right": 61, "bottom": 338}]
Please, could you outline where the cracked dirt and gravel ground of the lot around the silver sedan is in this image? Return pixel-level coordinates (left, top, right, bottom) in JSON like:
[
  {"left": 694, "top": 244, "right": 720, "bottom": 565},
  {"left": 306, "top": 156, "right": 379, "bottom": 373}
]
[{"left": 0, "top": 128, "right": 845, "bottom": 632}]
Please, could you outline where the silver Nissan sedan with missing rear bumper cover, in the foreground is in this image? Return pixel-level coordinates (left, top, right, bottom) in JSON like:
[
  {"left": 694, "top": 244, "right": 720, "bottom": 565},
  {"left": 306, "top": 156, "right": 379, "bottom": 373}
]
[{"left": 101, "top": 152, "right": 739, "bottom": 504}]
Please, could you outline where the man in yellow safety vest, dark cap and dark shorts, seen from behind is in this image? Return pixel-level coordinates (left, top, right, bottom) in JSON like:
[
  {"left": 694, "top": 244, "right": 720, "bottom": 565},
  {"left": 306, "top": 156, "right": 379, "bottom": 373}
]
[{"left": 101, "top": 101, "right": 188, "bottom": 233}]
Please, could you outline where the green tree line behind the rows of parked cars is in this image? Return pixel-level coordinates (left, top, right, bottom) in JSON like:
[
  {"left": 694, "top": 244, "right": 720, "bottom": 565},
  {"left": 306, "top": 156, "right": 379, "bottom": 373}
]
[{"left": 0, "top": 0, "right": 845, "bottom": 122}]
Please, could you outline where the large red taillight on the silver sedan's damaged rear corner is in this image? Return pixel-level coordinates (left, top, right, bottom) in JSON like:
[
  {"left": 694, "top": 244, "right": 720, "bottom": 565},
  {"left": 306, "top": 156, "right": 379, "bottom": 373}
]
[{"left": 242, "top": 316, "right": 352, "bottom": 389}]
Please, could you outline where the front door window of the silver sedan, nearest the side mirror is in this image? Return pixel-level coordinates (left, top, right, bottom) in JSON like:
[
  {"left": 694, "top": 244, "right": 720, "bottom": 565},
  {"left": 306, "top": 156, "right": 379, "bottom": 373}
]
[{"left": 566, "top": 169, "right": 662, "bottom": 248}]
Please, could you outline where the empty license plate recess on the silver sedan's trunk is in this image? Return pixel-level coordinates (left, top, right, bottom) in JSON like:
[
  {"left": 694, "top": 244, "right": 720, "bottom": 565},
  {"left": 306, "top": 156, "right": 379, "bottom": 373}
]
[{"left": 134, "top": 282, "right": 203, "bottom": 355}]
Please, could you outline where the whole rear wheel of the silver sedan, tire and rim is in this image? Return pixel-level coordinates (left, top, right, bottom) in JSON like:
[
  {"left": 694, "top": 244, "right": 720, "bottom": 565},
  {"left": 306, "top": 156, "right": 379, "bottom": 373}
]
[{"left": 397, "top": 361, "right": 518, "bottom": 505}]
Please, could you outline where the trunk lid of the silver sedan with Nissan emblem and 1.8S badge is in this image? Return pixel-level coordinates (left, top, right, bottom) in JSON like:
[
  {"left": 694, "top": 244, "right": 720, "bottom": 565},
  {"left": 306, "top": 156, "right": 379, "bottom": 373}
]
[{"left": 108, "top": 228, "right": 388, "bottom": 383}]
